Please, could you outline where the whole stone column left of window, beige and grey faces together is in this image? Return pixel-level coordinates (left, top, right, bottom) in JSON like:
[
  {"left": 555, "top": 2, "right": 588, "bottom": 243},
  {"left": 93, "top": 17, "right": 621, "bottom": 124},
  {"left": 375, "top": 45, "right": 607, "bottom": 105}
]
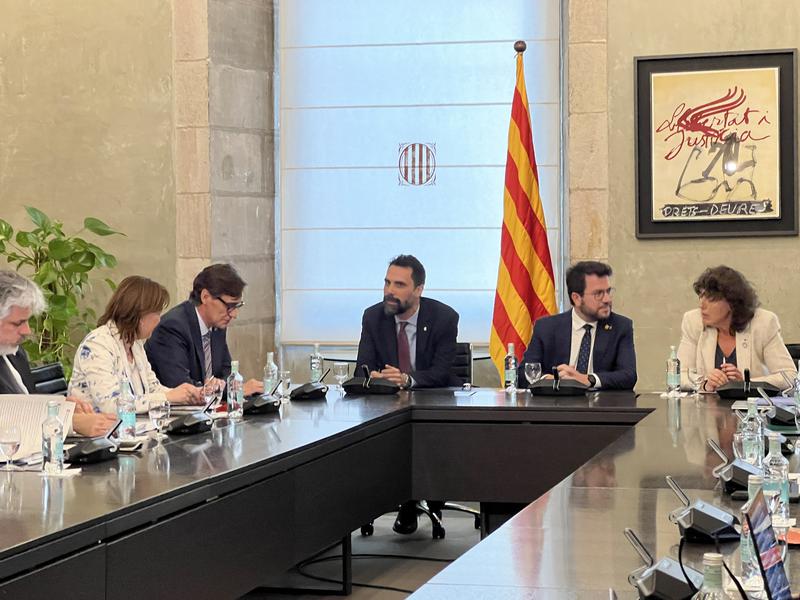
[{"left": 173, "top": 0, "right": 275, "bottom": 378}]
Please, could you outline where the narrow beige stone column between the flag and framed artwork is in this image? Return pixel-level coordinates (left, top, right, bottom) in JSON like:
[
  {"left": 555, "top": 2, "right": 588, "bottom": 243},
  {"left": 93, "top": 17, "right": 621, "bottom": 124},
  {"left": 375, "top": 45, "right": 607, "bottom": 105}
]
[{"left": 567, "top": 0, "right": 609, "bottom": 262}]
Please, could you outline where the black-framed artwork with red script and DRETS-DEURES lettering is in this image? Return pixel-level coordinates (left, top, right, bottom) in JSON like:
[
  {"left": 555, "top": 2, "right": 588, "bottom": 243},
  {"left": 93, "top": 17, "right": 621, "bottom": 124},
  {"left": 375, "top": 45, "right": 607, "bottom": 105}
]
[{"left": 634, "top": 50, "right": 798, "bottom": 238}]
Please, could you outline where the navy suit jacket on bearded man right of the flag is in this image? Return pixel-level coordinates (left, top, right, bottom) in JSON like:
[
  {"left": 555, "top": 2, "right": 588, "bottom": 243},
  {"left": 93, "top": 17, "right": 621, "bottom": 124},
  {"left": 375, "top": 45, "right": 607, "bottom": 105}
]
[{"left": 517, "top": 310, "right": 636, "bottom": 390}]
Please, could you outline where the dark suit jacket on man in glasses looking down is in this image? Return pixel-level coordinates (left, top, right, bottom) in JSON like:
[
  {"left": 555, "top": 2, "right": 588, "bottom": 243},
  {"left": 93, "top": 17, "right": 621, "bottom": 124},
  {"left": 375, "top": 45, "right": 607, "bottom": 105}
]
[{"left": 144, "top": 300, "right": 231, "bottom": 387}]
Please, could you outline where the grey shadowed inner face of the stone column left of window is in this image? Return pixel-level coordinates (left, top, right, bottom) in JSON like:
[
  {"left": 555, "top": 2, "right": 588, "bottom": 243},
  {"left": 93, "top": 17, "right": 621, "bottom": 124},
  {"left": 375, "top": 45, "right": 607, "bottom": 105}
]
[{"left": 208, "top": 0, "right": 275, "bottom": 378}]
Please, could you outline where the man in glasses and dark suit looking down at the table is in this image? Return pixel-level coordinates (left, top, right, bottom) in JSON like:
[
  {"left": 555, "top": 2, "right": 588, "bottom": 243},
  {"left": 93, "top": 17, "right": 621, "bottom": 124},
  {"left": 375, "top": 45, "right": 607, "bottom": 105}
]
[{"left": 145, "top": 263, "right": 264, "bottom": 396}]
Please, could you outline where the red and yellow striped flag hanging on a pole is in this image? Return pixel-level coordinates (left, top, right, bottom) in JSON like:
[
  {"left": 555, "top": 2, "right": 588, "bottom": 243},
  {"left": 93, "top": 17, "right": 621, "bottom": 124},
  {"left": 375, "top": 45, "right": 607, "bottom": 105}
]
[{"left": 489, "top": 42, "right": 557, "bottom": 381}]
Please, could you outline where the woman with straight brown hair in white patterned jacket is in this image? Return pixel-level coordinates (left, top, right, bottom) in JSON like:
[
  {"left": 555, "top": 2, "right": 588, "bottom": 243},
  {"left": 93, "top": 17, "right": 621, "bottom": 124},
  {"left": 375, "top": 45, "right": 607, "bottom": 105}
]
[{"left": 69, "top": 275, "right": 202, "bottom": 413}]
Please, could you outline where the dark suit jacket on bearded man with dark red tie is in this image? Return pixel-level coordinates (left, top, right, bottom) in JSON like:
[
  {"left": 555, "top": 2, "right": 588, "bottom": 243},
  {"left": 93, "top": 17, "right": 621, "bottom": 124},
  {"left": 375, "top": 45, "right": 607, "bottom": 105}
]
[{"left": 356, "top": 297, "right": 461, "bottom": 387}]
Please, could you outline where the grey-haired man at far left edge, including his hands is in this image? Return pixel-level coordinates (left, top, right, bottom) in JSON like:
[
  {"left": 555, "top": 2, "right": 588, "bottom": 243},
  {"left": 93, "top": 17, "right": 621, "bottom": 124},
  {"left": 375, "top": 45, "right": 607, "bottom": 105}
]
[{"left": 0, "top": 271, "right": 117, "bottom": 437}]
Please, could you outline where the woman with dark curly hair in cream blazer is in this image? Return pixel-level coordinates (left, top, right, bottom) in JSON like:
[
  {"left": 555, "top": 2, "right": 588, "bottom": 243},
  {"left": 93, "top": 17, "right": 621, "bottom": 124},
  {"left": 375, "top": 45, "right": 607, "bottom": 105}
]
[{"left": 678, "top": 265, "right": 797, "bottom": 391}]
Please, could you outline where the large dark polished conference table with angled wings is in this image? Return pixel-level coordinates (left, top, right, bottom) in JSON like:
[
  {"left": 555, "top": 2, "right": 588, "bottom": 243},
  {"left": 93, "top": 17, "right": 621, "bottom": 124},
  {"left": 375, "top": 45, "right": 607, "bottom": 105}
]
[{"left": 0, "top": 390, "right": 780, "bottom": 599}]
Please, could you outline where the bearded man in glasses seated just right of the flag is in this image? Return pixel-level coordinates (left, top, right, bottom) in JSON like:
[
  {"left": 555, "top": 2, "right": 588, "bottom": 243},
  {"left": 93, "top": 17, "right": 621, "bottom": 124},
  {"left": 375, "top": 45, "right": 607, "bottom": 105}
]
[{"left": 517, "top": 261, "right": 636, "bottom": 390}]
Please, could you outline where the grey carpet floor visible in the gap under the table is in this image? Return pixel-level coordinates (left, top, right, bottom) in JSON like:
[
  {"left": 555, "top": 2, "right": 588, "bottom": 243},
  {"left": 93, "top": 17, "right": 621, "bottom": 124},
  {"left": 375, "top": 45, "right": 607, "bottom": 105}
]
[{"left": 244, "top": 504, "right": 480, "bottom": 600}]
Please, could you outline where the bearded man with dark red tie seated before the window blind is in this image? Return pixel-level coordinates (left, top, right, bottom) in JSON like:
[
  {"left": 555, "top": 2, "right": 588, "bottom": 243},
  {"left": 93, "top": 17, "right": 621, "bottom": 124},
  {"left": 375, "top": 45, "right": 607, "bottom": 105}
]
[{"left": 356, "top": 254, "right": 460, "bottom": 534}]
